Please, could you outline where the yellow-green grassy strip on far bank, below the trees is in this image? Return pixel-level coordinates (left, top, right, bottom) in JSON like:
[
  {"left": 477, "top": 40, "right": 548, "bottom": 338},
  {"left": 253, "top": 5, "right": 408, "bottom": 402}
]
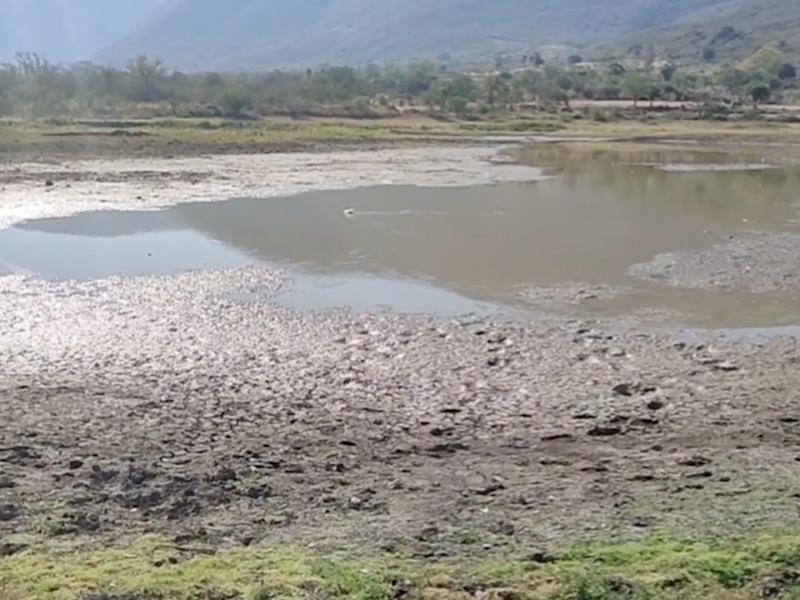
[{"left": 0, "top": 113, "right": 800, "bottom": 160}]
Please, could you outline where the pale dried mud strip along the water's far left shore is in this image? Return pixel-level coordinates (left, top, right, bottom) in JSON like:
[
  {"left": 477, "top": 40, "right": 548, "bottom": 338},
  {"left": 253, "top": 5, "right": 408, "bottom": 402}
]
[{"left": 0, "top": 145, "right": 547, "bottom": 228}]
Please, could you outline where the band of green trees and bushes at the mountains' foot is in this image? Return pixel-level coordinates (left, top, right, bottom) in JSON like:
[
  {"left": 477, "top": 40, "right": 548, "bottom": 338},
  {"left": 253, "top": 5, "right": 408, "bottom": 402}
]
[{"left": 0, "top": 48, "right": 797, "bottom": 118}]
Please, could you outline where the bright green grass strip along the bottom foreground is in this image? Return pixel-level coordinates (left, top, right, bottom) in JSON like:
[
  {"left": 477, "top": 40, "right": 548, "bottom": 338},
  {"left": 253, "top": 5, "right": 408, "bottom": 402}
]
[{"left": 0, "top": 533, "right": 800, "bottom": 600}]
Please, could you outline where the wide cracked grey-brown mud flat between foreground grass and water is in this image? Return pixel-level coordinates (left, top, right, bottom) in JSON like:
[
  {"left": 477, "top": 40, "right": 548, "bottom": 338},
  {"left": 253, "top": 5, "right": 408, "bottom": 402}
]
[{"left": 0, "top": 269, "right": 800, "bottom": 556}]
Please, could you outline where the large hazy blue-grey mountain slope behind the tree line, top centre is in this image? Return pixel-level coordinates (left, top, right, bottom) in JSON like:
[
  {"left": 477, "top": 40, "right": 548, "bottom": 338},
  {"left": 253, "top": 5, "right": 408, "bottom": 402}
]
[{"left": 92, "top": 0, "right": 725, "bottom": 69}]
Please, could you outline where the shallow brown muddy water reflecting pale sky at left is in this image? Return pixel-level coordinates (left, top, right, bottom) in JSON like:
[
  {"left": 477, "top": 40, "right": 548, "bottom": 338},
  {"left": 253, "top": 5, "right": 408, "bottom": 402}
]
[{"left": 0, "top": 146, "right": 800, "bottom": 327}]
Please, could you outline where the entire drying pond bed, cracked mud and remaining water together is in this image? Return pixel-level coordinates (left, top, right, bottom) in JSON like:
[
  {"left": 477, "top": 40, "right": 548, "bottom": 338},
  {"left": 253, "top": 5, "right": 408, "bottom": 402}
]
[{"left": 0, "top": 144, "right": 800, "bottom": 568}]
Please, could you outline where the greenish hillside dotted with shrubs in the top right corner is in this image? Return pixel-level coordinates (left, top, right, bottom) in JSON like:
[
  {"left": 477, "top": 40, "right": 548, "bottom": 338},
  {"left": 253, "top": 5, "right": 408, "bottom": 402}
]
[{"left": 596, "top": 0, "right": 800, "bottom": 64}]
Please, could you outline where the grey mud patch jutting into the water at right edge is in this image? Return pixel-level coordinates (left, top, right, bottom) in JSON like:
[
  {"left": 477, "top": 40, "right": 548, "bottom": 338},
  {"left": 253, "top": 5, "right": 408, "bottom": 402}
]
[{"left": 628, "top": 231, "right": 800, "bottom": 293}]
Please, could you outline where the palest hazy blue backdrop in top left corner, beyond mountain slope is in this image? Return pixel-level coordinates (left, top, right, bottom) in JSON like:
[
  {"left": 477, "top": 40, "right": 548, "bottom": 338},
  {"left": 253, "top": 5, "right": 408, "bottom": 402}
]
[{"left": 0, "top": 0, "right": 167, "bottom": 62}]
